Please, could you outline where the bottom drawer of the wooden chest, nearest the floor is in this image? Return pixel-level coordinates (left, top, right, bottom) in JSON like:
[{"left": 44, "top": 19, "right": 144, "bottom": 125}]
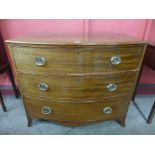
[{"left": 24, "top": 97, "right": 130, "bottom": 122}]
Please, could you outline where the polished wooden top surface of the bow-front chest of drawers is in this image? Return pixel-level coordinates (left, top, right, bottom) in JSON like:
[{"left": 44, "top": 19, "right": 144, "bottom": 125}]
[{"left": 6, "top": 33, "right": 146, "bottom": 45}]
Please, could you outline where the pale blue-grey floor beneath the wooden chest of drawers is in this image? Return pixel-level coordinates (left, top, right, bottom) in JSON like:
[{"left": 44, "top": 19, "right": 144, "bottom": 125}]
[{"left": 0, "top": 96, "right": 155, "bottom": 135}]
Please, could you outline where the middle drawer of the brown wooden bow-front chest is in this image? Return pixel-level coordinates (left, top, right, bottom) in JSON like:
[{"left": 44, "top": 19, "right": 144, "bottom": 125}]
[{"left": 19, "top": 73, "right": 136, "bottom": 101}]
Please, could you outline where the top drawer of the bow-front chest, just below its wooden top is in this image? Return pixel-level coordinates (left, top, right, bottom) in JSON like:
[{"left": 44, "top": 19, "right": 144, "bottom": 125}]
[{"left": 13, "top": 45, "right": 144, "bottom": 75}]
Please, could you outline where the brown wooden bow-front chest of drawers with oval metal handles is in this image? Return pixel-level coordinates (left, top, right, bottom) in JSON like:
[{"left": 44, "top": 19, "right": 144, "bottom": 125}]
[{"left": 6, "top": 34, "right": 146, "bottom": 126}]
